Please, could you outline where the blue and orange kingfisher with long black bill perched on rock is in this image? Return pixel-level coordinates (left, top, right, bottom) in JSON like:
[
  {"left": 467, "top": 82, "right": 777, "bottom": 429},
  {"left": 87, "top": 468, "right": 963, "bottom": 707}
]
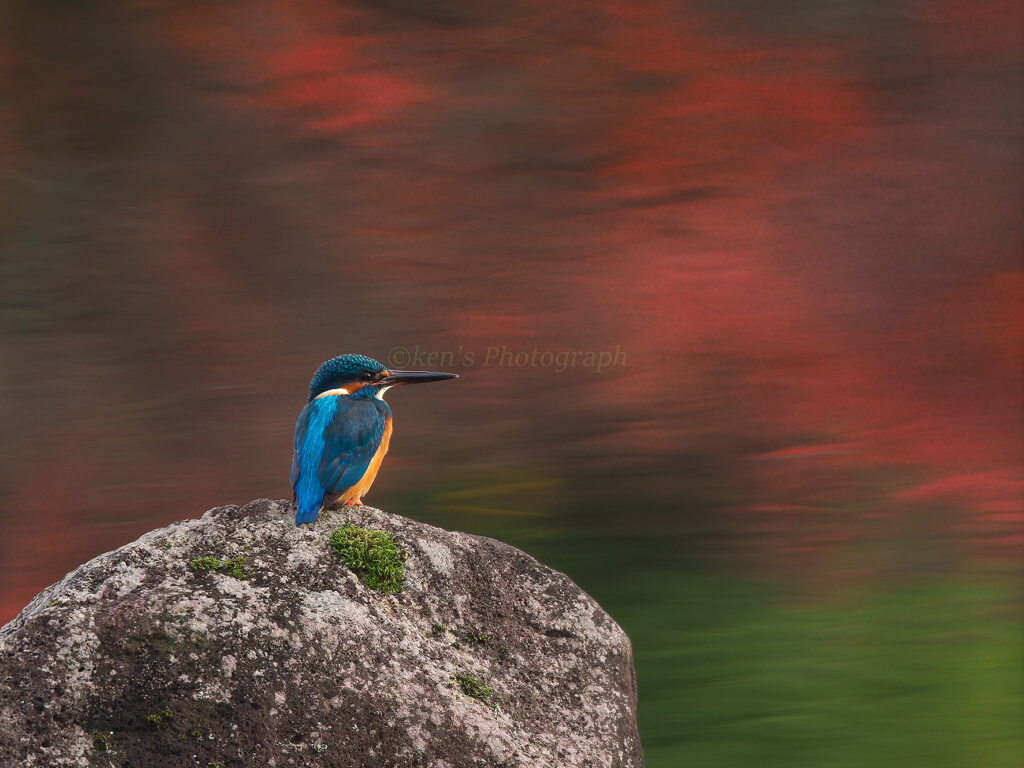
[{"left": 291, "top": 354, "right": 459, "bottom": 525}]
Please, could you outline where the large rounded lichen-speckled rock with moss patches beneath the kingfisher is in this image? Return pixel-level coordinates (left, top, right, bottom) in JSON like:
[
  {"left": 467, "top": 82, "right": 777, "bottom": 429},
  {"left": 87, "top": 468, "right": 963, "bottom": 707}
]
[{"left": 0, "top": 500, "right": 642, "bottom": 768}]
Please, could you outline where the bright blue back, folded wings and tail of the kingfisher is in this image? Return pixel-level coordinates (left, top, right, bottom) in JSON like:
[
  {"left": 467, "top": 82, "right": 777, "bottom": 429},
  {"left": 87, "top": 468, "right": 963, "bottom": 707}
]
[{"left": 292, "top": 396, "right": 386, "bottom": 523}]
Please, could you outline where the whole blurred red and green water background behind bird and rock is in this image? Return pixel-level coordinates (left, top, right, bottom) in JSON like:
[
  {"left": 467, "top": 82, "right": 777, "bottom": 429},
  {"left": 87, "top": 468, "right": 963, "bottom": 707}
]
[{"left": 0, "top": 0, "right": 1024, "bottom": 768}]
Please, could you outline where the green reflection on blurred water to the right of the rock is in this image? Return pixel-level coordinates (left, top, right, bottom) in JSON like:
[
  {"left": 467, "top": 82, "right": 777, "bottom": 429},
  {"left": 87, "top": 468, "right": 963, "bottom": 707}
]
[{"left": 403, "top": 500, "right": 1024, "bottom": 768}]
